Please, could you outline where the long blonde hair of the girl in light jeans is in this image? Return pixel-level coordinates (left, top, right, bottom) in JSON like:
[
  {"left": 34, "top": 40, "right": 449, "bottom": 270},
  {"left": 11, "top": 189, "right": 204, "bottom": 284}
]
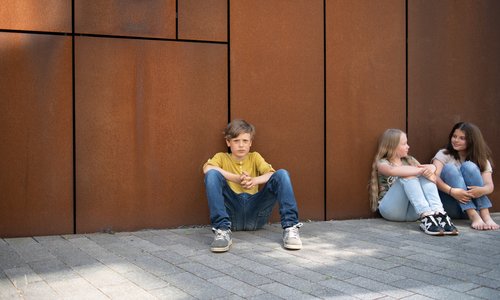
[{"left": 369, "top": 128, "right": 418, "bottom": 211}]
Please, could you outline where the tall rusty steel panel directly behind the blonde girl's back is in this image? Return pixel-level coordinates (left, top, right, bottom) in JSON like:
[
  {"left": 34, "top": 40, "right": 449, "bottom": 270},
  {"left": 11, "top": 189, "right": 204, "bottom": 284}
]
[{"left": 326, "top": 0, "right": 411, "bottom": 219}]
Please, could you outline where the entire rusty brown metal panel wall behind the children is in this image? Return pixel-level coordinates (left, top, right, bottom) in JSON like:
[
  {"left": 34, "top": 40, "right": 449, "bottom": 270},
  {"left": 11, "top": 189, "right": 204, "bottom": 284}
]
[{"left": 0, "top": 0, "right": 500, "bottom": 237}]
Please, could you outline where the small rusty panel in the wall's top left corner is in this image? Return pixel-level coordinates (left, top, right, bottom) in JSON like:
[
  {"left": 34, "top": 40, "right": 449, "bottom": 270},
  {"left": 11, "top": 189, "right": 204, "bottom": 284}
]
[{"left": 0, "top": 0, "right": 71, "bottom": 32}]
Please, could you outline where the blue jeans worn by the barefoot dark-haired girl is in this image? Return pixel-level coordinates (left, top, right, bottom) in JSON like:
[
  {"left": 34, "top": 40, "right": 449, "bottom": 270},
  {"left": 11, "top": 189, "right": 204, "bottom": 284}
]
[{"left": 439, "top": 161, "right": 491, "bottom": 219}]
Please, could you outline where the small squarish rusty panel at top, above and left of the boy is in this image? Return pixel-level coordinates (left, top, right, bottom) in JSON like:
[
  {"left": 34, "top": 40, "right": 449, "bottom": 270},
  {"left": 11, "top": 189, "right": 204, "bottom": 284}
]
[{"left": 178, "top": 0, "right": 228, "bottom": 42}]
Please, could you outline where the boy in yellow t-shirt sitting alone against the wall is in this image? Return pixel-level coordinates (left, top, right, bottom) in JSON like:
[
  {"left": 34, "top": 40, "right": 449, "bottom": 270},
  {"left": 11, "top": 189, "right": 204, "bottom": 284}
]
[{"left": 203, "top": 120, "right": 302, "bottom": 252}]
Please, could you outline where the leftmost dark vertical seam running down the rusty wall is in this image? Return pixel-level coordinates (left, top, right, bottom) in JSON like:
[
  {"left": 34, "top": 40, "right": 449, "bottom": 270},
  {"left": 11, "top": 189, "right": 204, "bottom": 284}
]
[{"left": 71, "top": 0, "right": 76, "bottom": 234}]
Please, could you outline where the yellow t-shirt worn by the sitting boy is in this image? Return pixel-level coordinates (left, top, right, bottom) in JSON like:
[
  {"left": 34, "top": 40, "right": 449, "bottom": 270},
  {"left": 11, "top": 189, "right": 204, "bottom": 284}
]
[{"left": 203, "top": 152, "right": 275, "bottom": 194}]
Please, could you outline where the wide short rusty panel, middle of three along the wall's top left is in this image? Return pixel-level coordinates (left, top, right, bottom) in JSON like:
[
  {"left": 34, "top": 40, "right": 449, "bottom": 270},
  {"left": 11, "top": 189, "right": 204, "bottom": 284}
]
[{"left": 75, "top": 0, "right": 175, "bottom": 39}]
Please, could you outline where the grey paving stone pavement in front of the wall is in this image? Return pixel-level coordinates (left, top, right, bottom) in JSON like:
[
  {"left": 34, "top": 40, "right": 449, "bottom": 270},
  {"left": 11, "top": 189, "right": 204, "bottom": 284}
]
[{"left": 0, "top": 213, "right": 500, "bottom": 299}]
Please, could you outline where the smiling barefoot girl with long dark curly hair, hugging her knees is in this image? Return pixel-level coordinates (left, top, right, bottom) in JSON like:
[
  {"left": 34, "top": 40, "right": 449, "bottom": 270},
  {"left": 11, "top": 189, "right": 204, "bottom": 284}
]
[{"left": 432, "top": 122, "right": 500, "bottom": 230}]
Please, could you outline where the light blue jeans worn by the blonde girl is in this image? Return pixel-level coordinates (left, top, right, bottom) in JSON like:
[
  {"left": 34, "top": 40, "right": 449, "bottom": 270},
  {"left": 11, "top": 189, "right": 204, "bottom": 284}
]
[{"left": 378, "top": 176, "right": 444, "bottom": 222}]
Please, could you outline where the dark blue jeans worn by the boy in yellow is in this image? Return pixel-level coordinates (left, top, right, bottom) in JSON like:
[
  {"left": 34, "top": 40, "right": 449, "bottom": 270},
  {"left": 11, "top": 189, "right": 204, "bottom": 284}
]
[{"left": 205, "top": 170, "right": 298, "bottom": 231}]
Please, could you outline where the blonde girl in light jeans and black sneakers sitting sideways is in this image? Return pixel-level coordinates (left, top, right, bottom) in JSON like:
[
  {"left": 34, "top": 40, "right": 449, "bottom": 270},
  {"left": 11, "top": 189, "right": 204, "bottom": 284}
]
[{"left": 370, "top": 129, "right": 458, "bottom": 235}]
